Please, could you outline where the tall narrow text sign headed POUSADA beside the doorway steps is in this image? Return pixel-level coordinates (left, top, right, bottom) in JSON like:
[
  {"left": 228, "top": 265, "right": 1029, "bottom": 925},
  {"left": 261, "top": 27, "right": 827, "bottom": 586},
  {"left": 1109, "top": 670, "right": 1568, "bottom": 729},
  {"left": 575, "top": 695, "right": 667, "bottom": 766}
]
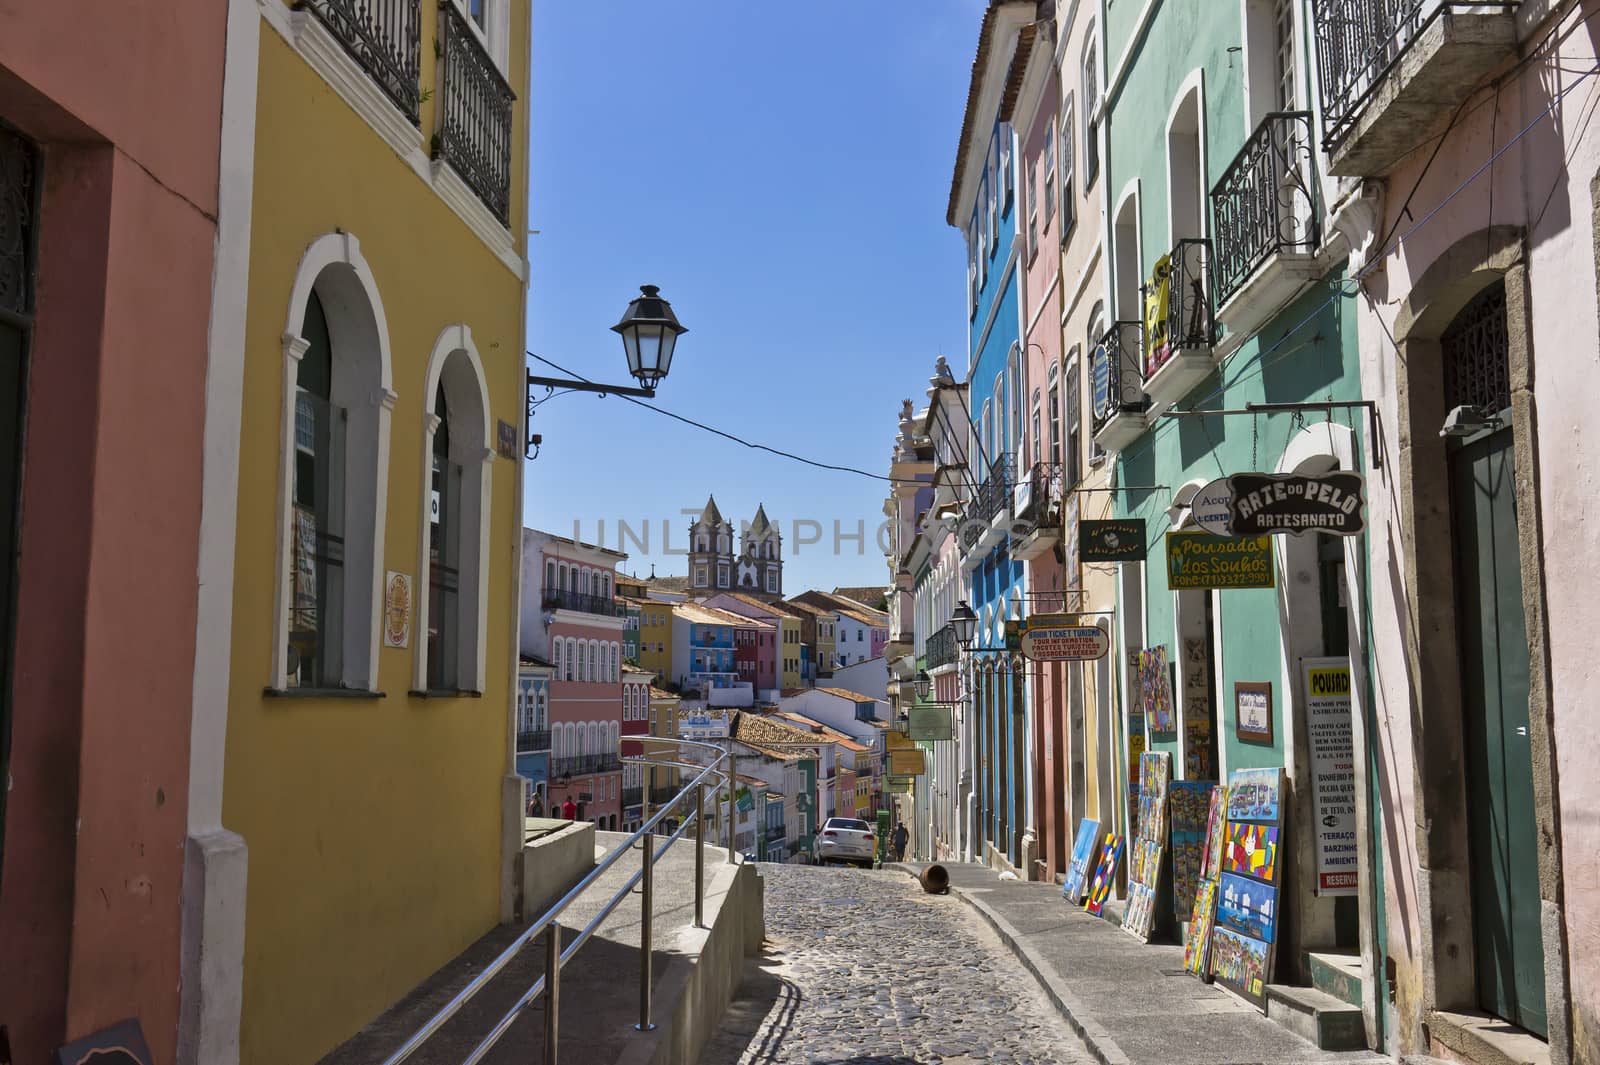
[{"left": 1301, "top": 659, "right": 1358, "bottom": 895}]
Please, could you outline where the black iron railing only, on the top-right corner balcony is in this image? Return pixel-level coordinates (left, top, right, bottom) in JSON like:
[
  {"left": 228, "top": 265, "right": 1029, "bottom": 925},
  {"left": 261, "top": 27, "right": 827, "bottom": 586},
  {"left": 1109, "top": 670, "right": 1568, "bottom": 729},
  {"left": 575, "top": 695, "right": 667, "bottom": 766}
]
[{"left": 1310, "top": 0, "right": 1517, "bottom": 149}]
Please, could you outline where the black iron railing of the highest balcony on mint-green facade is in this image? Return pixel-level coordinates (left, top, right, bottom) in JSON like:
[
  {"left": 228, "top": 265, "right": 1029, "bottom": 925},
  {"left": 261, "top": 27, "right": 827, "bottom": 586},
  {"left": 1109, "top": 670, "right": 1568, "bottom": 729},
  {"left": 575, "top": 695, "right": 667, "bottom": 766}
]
[{"left": 1211, "top": 110, "right": 1322, "bottom": 307}]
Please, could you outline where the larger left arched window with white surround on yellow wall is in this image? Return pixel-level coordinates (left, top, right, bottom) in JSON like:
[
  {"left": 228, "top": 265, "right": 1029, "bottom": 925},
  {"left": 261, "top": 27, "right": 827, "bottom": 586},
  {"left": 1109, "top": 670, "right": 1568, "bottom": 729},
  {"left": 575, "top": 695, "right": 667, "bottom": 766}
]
[{"left": 270, "top": 233, "right": 395, "bottom": 689}]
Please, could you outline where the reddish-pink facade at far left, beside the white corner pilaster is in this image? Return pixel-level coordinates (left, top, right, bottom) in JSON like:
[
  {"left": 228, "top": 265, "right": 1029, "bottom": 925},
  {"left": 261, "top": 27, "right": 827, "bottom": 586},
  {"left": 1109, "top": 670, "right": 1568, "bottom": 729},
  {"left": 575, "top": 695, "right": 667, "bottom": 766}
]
[{"left": 0, "top": 0, "right": 227, "bottom": 1062}]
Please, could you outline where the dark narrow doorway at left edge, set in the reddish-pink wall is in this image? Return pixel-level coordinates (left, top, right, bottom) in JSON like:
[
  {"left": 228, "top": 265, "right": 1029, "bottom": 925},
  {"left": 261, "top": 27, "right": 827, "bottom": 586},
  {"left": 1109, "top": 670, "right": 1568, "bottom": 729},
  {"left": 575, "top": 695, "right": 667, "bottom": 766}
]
[{"left": 0, "top": 122, "right": 38, "bottom": 865}]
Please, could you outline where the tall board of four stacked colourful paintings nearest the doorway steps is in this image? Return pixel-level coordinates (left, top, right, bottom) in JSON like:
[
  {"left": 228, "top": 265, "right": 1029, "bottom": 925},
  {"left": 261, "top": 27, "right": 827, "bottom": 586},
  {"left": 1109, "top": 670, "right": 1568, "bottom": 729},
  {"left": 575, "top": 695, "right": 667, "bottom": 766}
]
[{"left": 1210, "top": 769, "right": 1283, "bottom": 1011}]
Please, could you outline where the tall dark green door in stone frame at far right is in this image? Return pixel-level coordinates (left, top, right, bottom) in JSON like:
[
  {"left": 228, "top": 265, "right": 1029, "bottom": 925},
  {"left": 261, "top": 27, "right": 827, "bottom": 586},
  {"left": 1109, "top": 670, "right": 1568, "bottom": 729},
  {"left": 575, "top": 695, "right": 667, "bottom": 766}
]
[{"left": 1450, "top": 419, "right": 1546, "bottom": 1036}]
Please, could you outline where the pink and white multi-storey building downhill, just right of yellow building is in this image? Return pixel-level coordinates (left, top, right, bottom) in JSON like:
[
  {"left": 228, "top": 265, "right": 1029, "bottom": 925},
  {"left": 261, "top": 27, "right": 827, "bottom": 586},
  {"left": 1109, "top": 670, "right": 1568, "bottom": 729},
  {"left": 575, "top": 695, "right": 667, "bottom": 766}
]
[{"left": 522, "top": 529, "right": 627, "bottom": 832}]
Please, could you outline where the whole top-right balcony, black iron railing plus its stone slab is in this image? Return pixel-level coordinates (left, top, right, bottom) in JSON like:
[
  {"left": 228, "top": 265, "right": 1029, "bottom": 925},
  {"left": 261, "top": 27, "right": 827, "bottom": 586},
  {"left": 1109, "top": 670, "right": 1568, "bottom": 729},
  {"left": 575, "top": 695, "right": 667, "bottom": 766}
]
[{"left": 1312, "top": 0, "right": 1517, "bottom": 164}]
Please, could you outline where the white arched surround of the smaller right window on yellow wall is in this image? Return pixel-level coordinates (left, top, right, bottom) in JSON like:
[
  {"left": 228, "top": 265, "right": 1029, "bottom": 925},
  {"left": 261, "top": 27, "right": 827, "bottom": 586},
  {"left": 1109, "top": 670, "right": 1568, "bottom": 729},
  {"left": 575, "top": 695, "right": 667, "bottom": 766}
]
[{"left": 411, "top": 323, "right": 494, "bottom": 691}]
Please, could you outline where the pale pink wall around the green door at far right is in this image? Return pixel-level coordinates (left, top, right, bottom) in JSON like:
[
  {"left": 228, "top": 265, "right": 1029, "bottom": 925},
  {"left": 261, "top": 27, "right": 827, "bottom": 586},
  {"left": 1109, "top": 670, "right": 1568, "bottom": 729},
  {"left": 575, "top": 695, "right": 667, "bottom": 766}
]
[{"left": 1360, "top": 3, "right": 1600, "bottom": 1062}]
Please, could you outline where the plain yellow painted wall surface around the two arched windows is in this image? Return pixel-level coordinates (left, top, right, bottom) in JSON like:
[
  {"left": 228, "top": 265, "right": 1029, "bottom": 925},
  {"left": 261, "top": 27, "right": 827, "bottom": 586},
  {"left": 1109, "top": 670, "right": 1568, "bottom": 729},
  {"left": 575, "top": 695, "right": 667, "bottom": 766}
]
[{"left": 222, "top": 0, "right": 530, "bottom": 1065}]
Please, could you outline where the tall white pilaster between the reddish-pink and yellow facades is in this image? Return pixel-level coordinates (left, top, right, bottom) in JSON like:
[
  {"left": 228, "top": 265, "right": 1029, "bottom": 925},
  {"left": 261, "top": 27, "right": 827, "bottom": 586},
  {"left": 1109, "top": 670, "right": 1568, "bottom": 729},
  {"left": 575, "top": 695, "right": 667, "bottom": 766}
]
[{"left": 174, "top": 0, "right": 261, "bottom": 1065}]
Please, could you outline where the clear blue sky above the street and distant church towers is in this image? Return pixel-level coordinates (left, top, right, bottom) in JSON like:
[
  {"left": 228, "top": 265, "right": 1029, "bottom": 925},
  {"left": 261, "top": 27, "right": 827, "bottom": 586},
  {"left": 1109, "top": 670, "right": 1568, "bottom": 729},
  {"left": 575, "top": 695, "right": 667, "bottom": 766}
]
[{"left": 525, "top": 0, "right": 982, "bottom": 593}]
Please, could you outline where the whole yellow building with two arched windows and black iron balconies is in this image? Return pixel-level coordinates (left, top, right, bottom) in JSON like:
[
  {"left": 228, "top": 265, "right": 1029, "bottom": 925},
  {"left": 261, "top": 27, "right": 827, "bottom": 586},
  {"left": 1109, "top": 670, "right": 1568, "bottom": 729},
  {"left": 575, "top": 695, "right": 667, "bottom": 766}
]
[{"left": 184, "top": 0, "right": 530, "bottom": 1065}]
